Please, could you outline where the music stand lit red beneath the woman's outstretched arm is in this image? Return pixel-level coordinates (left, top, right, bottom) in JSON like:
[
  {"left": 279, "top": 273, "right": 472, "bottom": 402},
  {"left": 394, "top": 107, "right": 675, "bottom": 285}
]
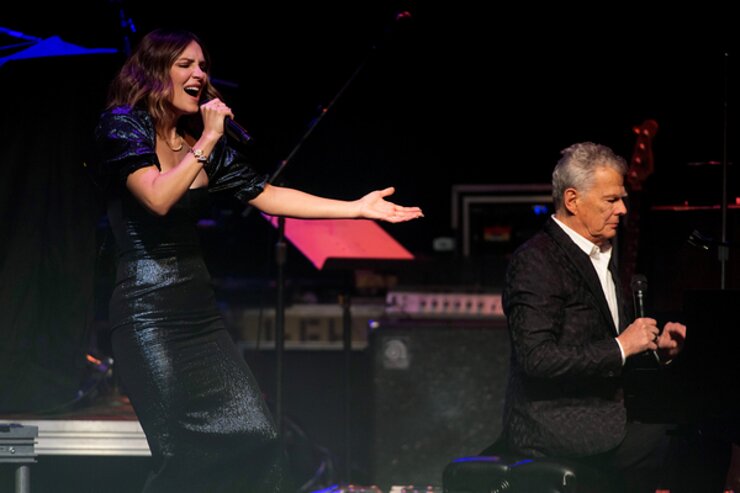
[{"left": 262, "top": 213, "right": 414, "bottom": 484}]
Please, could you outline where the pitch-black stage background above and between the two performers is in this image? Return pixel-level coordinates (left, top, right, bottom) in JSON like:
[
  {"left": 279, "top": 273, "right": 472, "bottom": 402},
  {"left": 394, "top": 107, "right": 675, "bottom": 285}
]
[{"left": 7, "top": 0, "right": 740, "bottom": 253}]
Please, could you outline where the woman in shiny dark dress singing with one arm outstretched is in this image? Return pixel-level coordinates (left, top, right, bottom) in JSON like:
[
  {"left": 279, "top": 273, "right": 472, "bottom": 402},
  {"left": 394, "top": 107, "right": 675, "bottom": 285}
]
[{"left": 95, "top": 30, "right": 422, "bottom": 493}]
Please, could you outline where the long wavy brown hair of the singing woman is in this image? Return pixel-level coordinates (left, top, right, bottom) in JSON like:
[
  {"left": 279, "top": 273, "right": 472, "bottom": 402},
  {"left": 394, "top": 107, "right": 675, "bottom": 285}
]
[{"left": 107, "top": 29, "right": 221, "bottom": 133}]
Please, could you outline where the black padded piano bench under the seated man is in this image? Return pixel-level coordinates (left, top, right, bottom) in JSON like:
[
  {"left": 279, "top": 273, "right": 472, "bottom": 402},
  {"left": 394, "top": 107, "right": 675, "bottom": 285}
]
[{"left": 442, "top": 453, "right": 605, "bottom": 493}]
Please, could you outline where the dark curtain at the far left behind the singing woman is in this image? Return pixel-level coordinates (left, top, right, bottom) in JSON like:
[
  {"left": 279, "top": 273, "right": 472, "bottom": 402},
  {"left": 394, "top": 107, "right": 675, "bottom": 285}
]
[{"left": 0, "top": 56, "right": 118, "bottom": 412}]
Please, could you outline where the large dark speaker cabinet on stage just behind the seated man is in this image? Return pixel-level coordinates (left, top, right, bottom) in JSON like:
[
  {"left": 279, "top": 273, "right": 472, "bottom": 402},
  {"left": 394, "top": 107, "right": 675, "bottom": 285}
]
[{"left": 370, "top": 319, "right": 510, "bottom": 490}]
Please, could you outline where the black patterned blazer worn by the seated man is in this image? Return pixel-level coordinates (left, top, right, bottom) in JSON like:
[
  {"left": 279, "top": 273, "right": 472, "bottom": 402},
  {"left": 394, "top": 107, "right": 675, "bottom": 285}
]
[{"left": 502, "top": 218, "right": 627, "bottom": 457}]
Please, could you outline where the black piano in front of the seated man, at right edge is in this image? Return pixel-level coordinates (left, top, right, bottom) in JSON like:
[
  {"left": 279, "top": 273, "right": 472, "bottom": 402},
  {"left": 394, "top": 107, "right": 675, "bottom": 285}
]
[{"left": 625, "top": 191, "right": 740, "bottom": 492}]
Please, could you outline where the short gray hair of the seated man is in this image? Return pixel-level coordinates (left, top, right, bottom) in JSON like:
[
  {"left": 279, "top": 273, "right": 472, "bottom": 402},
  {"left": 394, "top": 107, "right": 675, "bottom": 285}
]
[{"left": 552, "top": 142, "right": 627, "bottom": 211}]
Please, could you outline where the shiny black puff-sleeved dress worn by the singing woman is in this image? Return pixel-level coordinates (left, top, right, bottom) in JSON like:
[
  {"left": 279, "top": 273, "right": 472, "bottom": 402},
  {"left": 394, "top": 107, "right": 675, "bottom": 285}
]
[{"left": 96, "top": 107, "right": 287, "bottom": 493}]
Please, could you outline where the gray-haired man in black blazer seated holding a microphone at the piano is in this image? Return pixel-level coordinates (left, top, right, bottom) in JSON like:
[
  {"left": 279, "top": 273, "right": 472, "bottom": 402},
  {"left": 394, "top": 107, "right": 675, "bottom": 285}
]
[{"left": 502, "top": 142, "right": 686, "bottom": 493}]
